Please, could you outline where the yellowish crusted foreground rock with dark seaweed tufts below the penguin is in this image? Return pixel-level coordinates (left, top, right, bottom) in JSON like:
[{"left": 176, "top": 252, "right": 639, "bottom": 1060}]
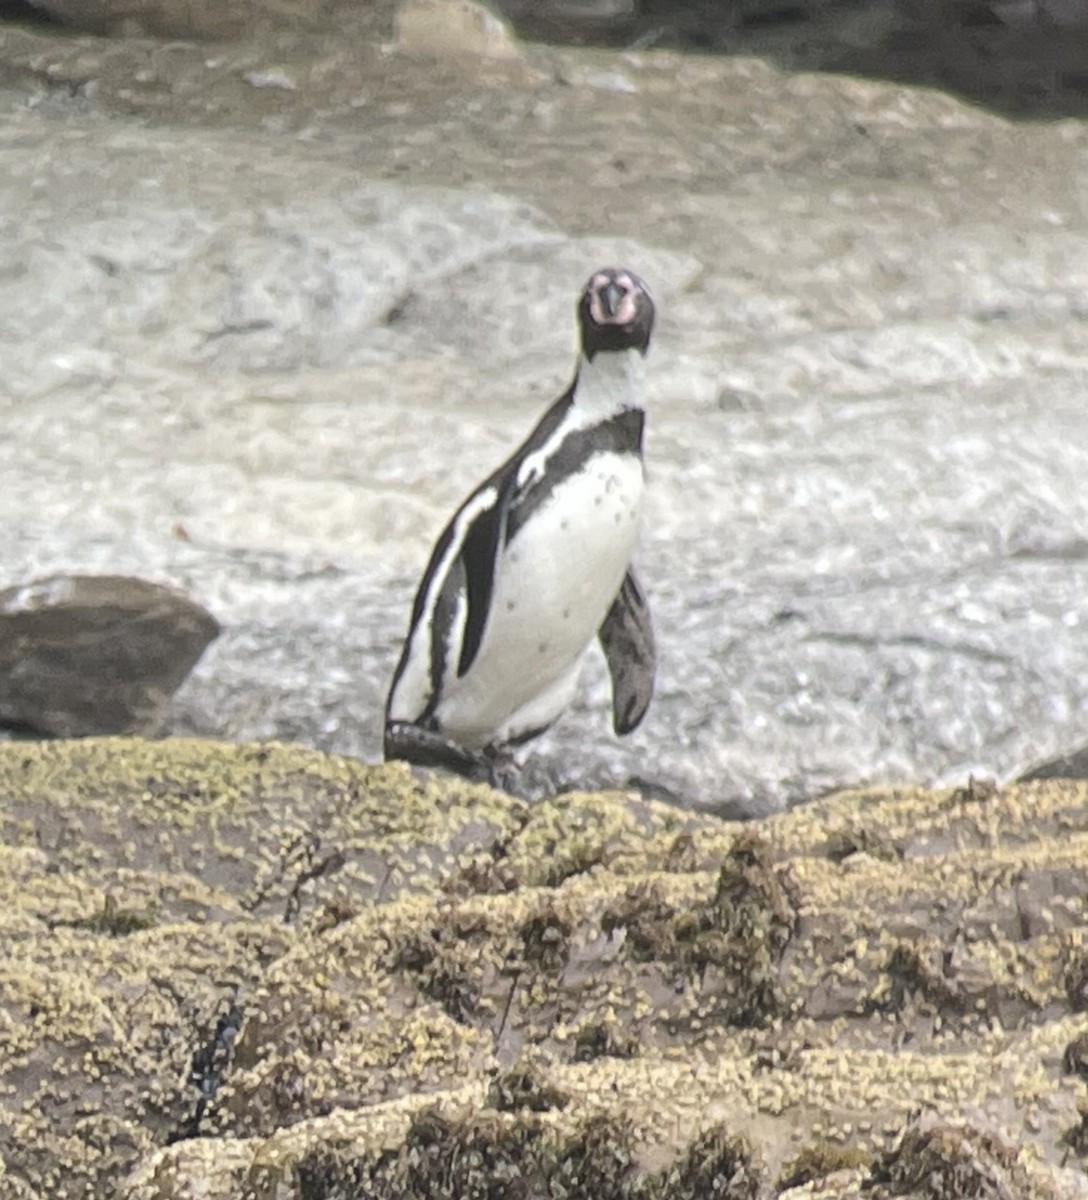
[{"left": 0, "top": 740, "right": 1088, "bottom": 1200}]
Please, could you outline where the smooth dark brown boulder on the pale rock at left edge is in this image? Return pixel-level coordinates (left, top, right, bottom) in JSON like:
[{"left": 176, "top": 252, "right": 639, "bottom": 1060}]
[{"left": 0, "top": 575, "right": 220, "bottom": 737}]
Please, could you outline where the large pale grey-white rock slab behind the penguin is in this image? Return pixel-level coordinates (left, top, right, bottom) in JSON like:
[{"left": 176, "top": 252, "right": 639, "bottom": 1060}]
[{"left": 0, "top": 5, "right": 1088, "bottom": 812}]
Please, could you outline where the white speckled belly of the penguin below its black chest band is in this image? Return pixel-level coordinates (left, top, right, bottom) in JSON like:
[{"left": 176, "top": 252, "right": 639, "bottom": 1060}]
[{"left": 437, "top": 454, "right": 643, "bottom": 746}]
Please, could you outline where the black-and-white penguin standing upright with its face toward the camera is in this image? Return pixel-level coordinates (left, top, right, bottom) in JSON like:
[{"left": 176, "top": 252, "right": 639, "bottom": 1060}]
[{"left": 384, "top": 268, "right": 655, "bottom": 782}]
